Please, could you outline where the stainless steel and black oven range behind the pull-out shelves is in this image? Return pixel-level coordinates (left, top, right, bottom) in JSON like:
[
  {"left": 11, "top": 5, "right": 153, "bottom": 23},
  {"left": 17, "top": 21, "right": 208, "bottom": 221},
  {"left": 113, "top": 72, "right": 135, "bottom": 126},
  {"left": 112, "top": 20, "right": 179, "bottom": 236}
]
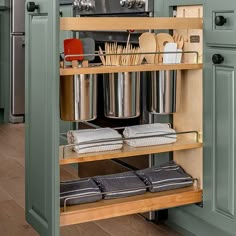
[{"left": 72, "top": 0, "right": 157, "bottom": 220}]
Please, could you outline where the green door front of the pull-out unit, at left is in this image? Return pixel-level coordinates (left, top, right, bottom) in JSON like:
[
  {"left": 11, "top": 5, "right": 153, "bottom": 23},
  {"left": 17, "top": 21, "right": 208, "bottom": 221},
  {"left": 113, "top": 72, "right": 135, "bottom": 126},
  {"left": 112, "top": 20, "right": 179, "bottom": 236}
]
[{"left": 25, "top": 0, "right": 59, "bottom": 236}]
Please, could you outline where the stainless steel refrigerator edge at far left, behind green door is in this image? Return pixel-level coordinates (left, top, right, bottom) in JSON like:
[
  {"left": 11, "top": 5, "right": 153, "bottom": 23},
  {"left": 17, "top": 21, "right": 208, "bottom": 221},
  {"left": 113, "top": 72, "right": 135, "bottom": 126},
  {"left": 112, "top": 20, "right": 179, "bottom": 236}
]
[{"left": 9, "top": 0, "right": 25, "bottom": 123}]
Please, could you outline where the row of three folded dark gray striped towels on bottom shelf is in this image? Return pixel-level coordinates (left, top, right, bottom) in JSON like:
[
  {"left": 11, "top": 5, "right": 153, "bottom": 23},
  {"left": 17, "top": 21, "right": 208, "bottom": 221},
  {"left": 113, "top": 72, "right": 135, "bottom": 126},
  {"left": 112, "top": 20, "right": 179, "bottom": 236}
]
[{"left": 60, "top": 161, "right": 193, "bottom": 206}]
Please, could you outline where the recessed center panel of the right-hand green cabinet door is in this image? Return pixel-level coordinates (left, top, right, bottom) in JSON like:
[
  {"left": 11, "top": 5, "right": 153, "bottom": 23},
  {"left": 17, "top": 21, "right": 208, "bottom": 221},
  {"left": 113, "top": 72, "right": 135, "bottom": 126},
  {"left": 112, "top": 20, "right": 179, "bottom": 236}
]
[{"left": 212, "top": 66, "right": 235, "bottom": 218}]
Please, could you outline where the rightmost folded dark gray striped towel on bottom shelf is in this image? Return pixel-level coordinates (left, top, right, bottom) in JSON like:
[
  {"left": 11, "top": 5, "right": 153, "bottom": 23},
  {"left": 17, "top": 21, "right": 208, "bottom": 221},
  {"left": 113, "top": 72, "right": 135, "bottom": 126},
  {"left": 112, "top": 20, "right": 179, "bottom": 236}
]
[{"left": 136, "top": 161, "right": 193, "bottom": 192}]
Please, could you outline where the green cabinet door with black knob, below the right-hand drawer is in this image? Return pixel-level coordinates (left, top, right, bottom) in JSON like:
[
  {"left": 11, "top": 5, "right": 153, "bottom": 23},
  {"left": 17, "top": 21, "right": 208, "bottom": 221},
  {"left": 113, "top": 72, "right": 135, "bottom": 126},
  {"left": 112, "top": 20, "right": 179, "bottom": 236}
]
[{"left": 204, "top": 48, "right": 236, "bottom": 233}]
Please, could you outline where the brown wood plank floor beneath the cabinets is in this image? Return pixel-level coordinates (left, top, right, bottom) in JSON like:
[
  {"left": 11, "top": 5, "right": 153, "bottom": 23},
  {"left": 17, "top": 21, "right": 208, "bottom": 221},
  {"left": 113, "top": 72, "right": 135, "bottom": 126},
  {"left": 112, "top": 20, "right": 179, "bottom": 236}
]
[{"left": 0, "top": 124, "right": 183, "bottom": 236}]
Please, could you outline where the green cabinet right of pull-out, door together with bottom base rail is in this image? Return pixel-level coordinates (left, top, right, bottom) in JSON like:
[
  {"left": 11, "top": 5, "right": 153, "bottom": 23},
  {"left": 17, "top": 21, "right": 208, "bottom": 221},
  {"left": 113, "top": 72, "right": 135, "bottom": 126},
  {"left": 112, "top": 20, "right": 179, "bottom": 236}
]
[{"left": 166, "top": 48, "right": 236, "bottom": 236}]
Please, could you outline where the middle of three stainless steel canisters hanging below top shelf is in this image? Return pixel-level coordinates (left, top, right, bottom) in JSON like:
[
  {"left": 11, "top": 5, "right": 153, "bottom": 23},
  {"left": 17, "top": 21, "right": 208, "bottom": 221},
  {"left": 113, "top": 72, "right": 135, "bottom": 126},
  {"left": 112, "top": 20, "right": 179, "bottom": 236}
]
[{"left": 103, "top": 72, "right": 140, "bottom": 119}]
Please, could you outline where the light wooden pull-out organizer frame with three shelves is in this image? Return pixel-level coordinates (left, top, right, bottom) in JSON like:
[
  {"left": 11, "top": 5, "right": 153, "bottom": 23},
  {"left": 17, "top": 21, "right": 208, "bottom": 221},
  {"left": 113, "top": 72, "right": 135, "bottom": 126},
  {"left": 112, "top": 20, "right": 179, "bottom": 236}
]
[{"left": 59, "top": 17, "right": 202, "bottom": 226}]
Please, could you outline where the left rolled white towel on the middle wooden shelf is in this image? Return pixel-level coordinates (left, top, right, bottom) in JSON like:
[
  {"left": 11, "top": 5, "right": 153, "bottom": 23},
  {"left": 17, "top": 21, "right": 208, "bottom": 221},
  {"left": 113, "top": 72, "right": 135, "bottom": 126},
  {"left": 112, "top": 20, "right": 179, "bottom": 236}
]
[{"left": 67, "top": 128, "right": 123, "bottom": 153}]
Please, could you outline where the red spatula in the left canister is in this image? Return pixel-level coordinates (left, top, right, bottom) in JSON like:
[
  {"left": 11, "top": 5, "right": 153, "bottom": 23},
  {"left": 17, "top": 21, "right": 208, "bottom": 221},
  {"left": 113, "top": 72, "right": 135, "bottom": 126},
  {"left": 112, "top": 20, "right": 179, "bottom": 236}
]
[{"left": 64, "top": 38, "right": 84, "bottom": 67}]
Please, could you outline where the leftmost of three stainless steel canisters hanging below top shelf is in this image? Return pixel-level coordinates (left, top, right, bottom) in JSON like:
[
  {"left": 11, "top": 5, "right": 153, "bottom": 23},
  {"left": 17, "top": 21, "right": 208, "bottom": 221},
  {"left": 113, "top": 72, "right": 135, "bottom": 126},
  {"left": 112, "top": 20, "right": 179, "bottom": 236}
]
[{"left": 60, "top": 74, "right": 97, "bottom": 121}]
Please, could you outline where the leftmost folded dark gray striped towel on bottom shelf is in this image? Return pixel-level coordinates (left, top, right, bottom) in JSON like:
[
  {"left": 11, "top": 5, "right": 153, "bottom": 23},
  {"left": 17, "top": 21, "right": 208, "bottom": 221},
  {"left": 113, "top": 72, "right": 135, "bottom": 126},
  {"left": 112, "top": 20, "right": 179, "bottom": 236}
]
[{"left": 60, "top": 178, "right": 102, "bottom": 206}]
